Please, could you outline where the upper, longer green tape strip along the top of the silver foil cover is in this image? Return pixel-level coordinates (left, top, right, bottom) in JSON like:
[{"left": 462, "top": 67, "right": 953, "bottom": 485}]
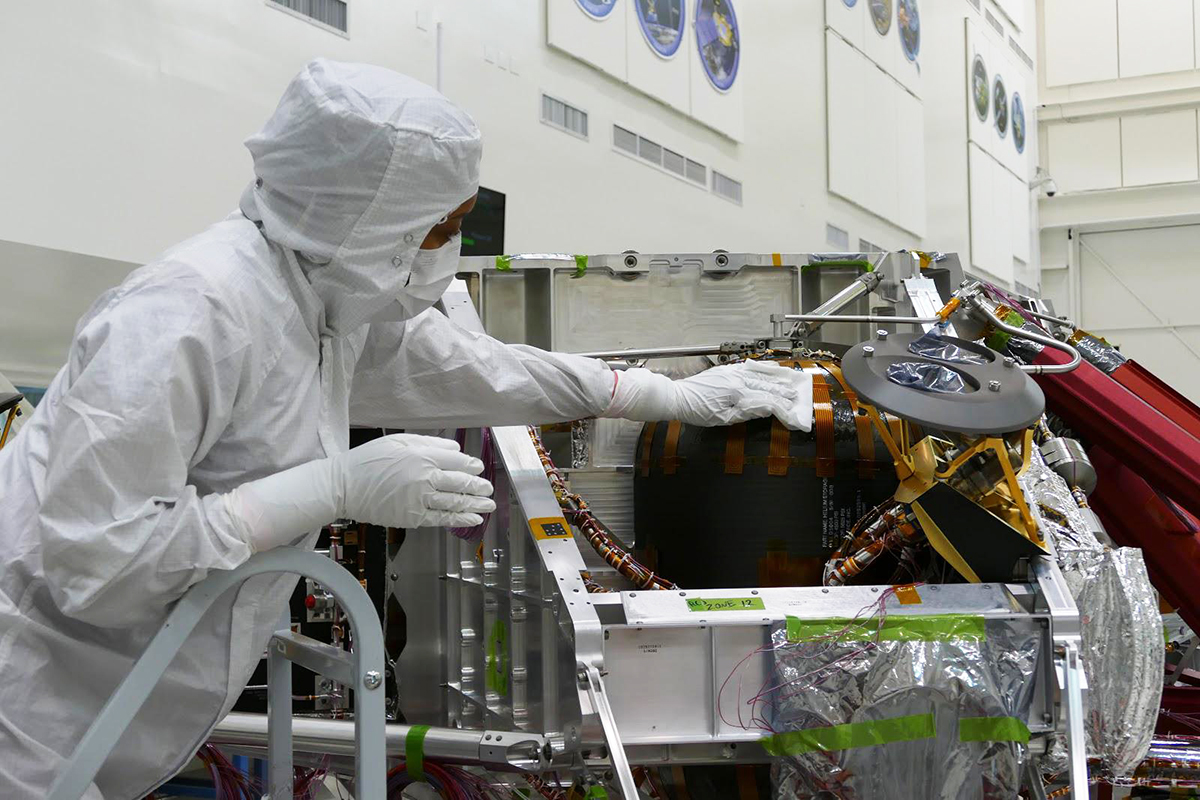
[{"left": 787, "top": 614, "right": 986, "bottom": 642}]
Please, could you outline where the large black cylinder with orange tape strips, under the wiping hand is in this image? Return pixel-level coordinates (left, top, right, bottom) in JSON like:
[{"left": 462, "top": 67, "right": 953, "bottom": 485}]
[{"left": 634, "top": 365, "right": 896, "bottom": 589}]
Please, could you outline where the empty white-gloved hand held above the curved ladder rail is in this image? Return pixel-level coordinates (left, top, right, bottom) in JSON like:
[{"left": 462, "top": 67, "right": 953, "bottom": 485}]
[{"left": 224, "top": 433, "right": 496, "bottom": 553}]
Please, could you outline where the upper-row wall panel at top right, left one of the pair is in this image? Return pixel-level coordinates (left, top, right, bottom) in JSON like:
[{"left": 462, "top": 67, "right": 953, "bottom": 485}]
[{"left": 1042, "top": 0, "right": 1118, "bottom": 86}]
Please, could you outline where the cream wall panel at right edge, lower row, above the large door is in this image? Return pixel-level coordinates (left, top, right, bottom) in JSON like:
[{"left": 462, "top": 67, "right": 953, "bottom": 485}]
[{"left": 1121, "top": 108, "right": 1200, "bottom": 186}]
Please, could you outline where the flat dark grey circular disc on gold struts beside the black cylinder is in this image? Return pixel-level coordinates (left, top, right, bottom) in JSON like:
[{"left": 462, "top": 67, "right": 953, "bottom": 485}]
[{"left": 841, "top": 333, "right": 1045, "bottom": 434}]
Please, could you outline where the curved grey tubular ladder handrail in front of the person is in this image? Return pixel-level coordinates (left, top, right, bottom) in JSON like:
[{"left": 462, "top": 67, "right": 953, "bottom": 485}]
[{"left": 49, "top": 547, "right": 386, "bottom": 800}]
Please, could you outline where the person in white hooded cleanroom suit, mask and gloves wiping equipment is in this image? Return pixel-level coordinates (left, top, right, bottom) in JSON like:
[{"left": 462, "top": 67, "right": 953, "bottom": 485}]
[{"left": 0, "top": 60, "right": 811, "bottom": 800}]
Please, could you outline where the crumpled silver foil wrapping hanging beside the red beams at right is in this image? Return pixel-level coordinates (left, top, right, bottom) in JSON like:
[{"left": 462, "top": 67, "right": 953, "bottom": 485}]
[{"left": 1020, "top": 452, "right": 1164, "bottom": 776}]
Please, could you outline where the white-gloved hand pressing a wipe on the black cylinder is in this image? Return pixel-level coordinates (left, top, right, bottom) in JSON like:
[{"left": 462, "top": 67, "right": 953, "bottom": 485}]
[{"left": 604, "top": 361, "right": 812, "bottom": 431}]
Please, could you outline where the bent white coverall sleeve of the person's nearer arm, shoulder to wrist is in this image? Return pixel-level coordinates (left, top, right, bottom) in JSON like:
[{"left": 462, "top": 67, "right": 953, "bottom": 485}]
[{"left": 37, "top": 275, "right": 251, "bottom": 627}]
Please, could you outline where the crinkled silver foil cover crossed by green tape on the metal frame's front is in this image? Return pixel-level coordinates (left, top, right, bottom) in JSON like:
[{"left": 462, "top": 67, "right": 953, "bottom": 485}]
[{"left": 767, "top": 615, "right": 1039, "bottom": 800}]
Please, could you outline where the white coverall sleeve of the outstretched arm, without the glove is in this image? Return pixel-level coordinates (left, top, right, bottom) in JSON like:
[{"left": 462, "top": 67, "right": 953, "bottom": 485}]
[{"left": 350, "top": 308, "right": 613, "bottom": 429}]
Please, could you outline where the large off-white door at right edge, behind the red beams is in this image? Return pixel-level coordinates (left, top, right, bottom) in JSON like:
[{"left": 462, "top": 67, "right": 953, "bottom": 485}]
[{"left": 1078, "top": 224, "right": 1200, "bottom": 403}]
